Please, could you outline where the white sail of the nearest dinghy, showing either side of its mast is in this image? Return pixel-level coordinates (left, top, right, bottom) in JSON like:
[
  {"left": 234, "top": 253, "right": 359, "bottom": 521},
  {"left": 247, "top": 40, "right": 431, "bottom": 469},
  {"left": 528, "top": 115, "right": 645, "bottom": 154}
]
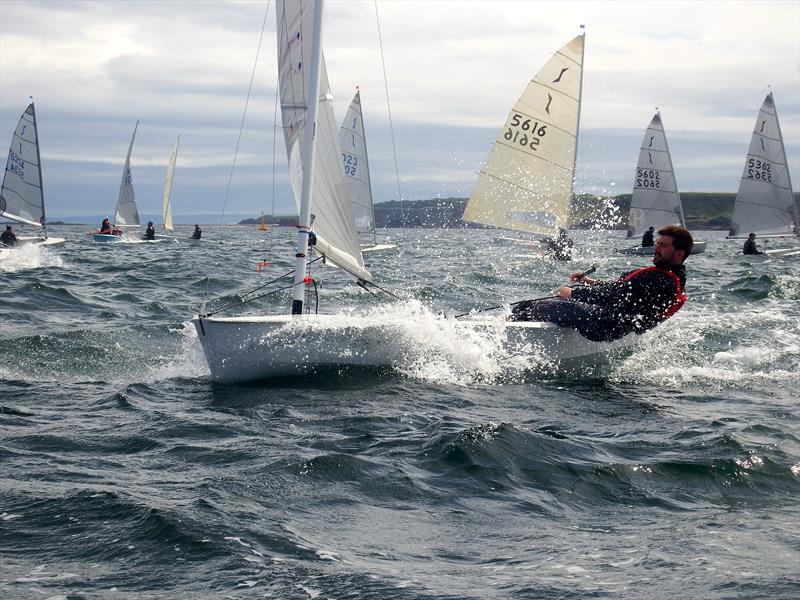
[{"left": 276, "top": 0, "right": 372, "bottom": 281}]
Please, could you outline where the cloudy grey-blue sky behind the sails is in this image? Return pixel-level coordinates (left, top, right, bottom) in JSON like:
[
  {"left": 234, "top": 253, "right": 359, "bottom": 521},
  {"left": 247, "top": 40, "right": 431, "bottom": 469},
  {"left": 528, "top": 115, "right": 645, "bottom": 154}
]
[{"left": 0, "top": 0, "right": 800, "bottom": 222}]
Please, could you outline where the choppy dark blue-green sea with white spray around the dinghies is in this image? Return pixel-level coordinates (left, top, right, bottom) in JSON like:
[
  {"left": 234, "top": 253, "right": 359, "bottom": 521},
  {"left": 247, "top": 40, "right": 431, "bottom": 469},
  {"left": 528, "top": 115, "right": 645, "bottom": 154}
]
[{"left": 0, "top": 225, "right": 800, "bottom": 600}]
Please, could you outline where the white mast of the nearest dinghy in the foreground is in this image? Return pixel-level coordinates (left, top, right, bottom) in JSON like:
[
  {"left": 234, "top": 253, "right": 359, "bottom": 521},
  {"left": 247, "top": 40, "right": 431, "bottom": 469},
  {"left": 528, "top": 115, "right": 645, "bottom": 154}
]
[{"left": 292, "top": 0, "right": 325, "bottom": 315}]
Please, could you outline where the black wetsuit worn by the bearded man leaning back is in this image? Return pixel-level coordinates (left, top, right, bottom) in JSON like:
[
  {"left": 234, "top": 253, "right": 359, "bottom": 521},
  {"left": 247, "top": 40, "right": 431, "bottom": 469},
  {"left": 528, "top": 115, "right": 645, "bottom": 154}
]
[{"left": 511, "top": 265, "right": 686, "bottom": 342}]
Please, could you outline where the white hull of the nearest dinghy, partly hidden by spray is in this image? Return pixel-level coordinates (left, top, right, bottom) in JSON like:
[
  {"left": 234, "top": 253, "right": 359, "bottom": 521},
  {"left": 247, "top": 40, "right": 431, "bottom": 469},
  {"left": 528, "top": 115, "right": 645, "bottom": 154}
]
[{"left": 193, "top": 315, "right": 636, "bottom": 383}]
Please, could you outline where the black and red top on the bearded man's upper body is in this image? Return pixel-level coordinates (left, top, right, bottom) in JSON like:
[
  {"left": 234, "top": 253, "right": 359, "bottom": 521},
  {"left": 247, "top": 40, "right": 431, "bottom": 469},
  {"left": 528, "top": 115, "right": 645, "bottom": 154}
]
[{"left": 571, "top": 265, "right": 687, "bottom": 333}]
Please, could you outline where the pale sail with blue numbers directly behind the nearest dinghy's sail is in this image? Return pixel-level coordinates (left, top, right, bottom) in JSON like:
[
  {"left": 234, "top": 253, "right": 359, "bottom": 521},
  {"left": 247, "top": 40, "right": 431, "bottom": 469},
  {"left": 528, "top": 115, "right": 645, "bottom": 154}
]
[{"left": 339, "top": 91, "right": 375, "bottom": 232}]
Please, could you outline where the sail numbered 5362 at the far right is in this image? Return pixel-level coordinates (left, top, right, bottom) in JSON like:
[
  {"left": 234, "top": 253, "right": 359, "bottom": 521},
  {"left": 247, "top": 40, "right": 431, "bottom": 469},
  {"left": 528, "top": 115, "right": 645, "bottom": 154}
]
[{"left": 728, "top": 92, "right": 800, "bottom": 237}]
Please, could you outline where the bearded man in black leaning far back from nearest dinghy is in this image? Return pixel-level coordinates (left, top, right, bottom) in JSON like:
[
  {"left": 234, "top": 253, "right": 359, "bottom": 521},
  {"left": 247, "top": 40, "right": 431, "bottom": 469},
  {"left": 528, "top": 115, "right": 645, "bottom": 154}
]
[{"left": 510, "top": 225, "right": 694, "bottom": 342}]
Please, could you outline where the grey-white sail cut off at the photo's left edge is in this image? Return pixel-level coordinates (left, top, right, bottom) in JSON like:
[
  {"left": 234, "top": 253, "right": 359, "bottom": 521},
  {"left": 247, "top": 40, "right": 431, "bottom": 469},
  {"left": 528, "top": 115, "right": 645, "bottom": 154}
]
[{"left": 0, "top": 102, "right": 45, "bottom": 227}]
